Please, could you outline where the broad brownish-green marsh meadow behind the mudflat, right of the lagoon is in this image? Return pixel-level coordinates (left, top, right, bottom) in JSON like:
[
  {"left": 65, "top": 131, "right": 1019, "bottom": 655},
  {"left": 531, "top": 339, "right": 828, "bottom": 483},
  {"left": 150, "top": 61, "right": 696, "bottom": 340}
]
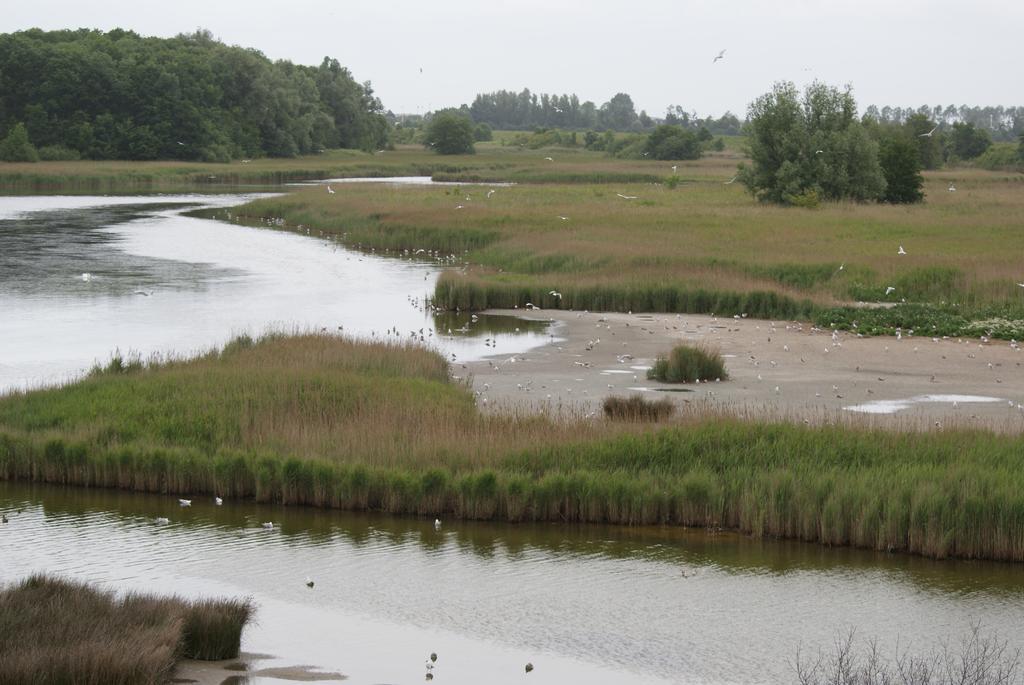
[{"left": 236, "top": 165, "right": 1024, "bottom": 338}]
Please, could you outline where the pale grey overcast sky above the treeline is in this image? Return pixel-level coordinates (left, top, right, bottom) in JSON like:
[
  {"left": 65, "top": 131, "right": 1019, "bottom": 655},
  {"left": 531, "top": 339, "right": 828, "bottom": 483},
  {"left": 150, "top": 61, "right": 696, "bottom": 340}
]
[{"left": 0, "top": 0, "right": 1024, "bottom": 116}]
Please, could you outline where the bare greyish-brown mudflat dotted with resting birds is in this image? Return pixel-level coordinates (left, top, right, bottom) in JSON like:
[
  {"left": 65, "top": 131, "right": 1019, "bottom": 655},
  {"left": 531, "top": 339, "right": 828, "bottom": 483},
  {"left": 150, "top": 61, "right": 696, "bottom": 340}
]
[{"left": 464, "top": 310, "right": 1024, "bottom": 431}]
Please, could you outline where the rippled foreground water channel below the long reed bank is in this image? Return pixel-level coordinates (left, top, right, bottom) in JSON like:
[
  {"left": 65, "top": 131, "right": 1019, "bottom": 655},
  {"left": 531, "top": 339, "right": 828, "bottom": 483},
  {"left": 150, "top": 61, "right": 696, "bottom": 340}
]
[{"left": 0, "top": 483, "right": 1024, "bottom": 683}]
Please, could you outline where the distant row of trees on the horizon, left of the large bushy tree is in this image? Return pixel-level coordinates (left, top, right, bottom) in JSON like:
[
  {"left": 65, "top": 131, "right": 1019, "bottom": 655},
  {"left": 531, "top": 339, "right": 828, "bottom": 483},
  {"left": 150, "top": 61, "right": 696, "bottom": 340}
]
[{"left": 461, "top": 88, "right": 741, "bottom": 135}]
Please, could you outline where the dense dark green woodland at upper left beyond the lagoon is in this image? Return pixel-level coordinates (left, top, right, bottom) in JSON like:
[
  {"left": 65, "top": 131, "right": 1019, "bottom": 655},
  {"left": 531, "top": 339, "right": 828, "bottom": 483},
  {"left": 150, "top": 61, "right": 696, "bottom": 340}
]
[{"left": 0, "top": 30, "right": 388, "bottom": 161}]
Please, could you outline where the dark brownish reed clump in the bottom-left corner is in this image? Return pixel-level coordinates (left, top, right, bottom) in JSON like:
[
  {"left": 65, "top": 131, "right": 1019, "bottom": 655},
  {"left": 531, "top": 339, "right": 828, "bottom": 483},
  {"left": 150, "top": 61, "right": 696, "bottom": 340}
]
[{"left": 0, "top": 575, "right": 253, "bottom": 685}]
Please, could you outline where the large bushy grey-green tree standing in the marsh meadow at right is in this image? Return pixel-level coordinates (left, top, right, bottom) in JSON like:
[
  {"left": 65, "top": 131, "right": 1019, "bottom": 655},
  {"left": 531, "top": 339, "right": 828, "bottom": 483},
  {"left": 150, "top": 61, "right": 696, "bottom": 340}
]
[{"left": 739, "top": 82, "right": 886, "bottom": 205}]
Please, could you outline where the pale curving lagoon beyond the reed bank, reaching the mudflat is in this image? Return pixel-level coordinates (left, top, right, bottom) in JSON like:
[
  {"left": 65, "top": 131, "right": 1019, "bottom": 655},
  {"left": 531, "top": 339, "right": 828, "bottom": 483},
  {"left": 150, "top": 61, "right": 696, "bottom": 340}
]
[{"left": 0, "top": 195, "right": 549, "bottom": 393}]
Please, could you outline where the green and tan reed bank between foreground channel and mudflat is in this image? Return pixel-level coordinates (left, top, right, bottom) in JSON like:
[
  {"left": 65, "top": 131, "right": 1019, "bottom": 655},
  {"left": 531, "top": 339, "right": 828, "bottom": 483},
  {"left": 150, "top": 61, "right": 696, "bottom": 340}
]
[{"left": 0, "top": 336, "right": 1024, "bottom": 561}]
